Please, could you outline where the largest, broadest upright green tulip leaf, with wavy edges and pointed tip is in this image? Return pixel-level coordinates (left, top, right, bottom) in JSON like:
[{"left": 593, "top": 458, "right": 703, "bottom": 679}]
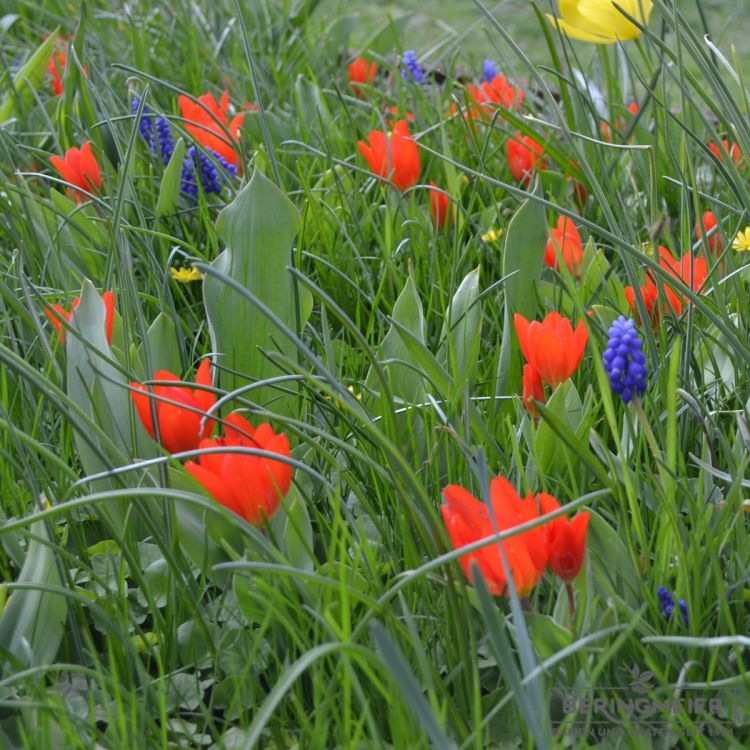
[{"left": 203, "top": 169, "right": 300, "bottom": 413}]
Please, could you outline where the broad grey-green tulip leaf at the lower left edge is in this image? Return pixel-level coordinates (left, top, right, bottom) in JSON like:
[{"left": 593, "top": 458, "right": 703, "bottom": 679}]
[{"left": 0, "top": 520, "right": 67, "bottom": 667}]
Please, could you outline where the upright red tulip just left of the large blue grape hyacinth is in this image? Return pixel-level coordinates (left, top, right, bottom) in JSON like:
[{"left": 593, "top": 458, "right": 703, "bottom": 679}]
[{"left": 513, "top": 312, "right": 589, "bottom": 388}]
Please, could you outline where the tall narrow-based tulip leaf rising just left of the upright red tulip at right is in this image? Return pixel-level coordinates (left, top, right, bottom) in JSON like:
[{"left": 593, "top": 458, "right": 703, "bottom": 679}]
[{"left": 495, "top": 180, "right": 547, "bottom": 403}]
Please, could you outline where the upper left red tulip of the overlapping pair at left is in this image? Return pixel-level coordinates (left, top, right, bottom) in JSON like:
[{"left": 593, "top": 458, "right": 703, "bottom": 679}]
[{"left": 130, "top": 359, "right": 216, "bottom": 453}]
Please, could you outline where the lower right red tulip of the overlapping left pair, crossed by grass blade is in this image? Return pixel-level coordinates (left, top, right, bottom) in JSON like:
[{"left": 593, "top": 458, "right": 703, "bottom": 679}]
[{"left": 185, "top": 412, "right": 292, "bottom": 526}]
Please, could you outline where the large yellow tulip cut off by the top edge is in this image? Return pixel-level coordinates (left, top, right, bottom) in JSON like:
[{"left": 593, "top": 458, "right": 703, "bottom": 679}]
[{"left": 547, "top": 0, "right": 653, "bottom": 44}]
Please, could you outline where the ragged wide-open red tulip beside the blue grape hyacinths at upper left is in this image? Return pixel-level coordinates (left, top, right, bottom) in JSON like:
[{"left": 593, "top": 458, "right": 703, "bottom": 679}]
[{"left": 178, "top": 90, "right": 245, "bottom": 170}]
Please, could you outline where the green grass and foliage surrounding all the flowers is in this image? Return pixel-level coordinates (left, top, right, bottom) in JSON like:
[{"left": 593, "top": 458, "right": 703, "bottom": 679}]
[{"left": 0, "top": 0, "right": 750, "bottom": 750}]
